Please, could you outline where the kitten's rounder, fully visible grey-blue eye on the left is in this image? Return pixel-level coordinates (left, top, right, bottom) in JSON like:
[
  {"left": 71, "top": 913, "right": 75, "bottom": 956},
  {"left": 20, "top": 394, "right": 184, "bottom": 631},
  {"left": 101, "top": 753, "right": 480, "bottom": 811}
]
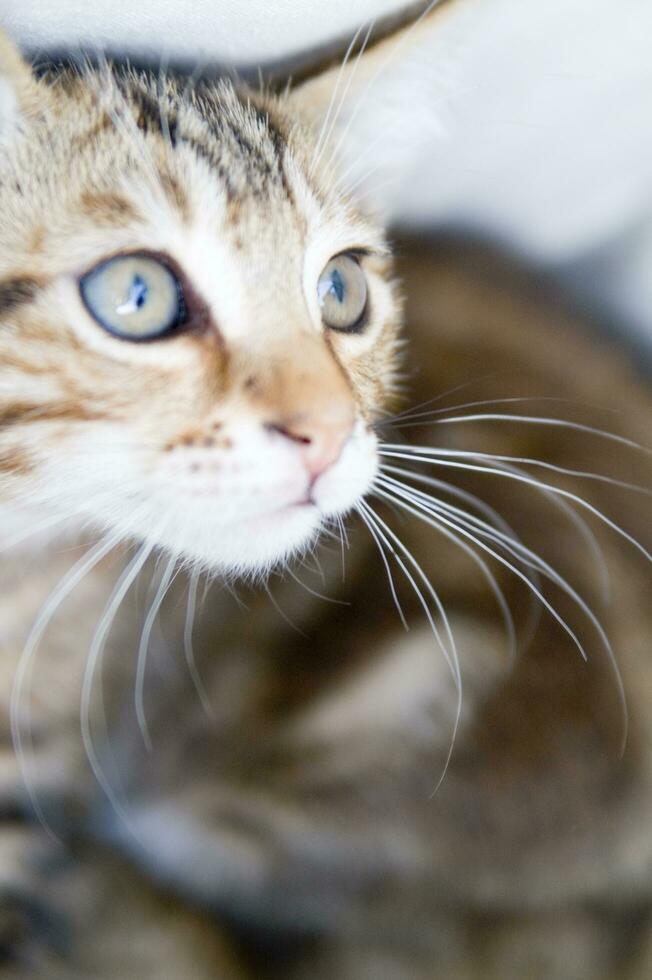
[{"left": 79, "top": 253, "right": 186, "bottom": 341}]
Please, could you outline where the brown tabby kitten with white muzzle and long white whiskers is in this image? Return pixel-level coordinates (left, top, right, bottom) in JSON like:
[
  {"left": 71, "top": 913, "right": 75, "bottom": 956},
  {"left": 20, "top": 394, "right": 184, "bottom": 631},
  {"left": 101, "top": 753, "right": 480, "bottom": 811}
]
[{"left": 0, "top": 13, "right": 650, "bottom": 980}]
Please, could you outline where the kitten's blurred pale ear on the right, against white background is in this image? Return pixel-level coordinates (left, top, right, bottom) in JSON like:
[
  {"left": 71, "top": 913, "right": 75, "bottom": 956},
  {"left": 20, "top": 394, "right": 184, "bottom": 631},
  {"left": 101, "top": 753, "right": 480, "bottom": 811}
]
[{"left": 288, "top": 0, "right": 468, "bottom": 208}]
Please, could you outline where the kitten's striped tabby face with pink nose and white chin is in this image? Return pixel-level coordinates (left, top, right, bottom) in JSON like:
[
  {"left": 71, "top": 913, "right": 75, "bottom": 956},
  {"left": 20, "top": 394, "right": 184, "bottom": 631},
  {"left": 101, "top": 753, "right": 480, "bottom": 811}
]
[{"left": 0, "top": 49, "right": 398, "bottom": 571}]
